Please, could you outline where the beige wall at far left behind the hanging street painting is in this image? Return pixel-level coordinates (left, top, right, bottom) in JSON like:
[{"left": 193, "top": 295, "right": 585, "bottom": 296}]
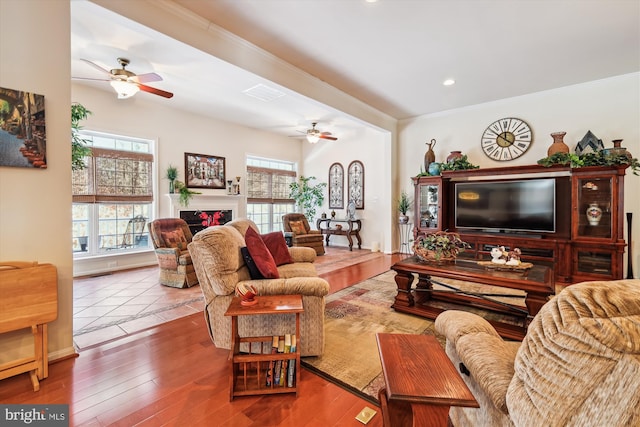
[{"left": 0, "top": 0, "right": 74, "bottom": 364}]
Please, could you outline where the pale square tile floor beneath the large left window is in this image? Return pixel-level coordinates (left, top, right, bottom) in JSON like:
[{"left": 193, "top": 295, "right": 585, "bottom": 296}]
[{"left": 73, "top": 267, "right": 204, "bottom": 351}]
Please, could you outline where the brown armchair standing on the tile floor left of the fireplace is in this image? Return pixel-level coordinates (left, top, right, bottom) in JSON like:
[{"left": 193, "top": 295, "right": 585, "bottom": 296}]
[{"left": 149, "top": 218, "right": 198, "bottom": 288}]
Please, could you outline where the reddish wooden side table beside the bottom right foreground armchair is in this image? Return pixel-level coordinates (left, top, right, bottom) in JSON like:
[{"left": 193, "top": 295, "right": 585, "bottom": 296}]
[{"left": 376, "top": 333, "right": 479, "bottom": 427}]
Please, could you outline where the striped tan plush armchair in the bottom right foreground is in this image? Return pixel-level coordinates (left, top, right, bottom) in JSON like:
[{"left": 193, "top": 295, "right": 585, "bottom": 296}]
[{"left": 435, "top": 280, "right": 640, "bottom": 427}]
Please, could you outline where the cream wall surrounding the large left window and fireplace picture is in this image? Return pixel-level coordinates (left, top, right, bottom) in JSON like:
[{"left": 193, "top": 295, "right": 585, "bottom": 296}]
[{"left": 72, "top": 84, "right": 303, "bottom": 276}]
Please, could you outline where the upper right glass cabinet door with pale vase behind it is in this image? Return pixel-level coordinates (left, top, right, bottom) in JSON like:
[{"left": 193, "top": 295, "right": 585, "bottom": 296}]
[{"left": 573, "top": 176, "right": 613, "bottom": 239}]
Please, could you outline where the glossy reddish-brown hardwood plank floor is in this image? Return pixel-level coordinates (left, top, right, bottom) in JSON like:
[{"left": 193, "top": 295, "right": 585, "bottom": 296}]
[{"left": 0, "top": 249, "right": 401, "bottom": 427}]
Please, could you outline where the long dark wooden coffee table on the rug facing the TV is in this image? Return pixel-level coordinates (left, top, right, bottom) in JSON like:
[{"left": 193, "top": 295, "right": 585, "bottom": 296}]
[{"left": 391, "top": 256, "right": 555, "bottom": 340}]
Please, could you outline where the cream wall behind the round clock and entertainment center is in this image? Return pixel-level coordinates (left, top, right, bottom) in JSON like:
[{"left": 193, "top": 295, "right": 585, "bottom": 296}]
[{"left": 398, "top": 73, "right": 640, "bottom": 277}]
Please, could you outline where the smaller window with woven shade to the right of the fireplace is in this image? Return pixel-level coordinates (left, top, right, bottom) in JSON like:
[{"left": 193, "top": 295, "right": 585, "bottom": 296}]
[{"left": 247, "top": 157, "right": 296, "bottom": 233}]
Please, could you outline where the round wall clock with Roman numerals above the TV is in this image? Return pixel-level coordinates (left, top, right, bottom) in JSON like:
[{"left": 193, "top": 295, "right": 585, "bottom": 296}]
[{"left": 482, "top": 117, "right": 533, "bottom": 162}]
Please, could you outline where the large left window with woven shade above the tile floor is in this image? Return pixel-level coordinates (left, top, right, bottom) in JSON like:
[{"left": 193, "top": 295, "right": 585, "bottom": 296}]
[{"left": 72, "top": 131, "right": 154, "bottom": 257}]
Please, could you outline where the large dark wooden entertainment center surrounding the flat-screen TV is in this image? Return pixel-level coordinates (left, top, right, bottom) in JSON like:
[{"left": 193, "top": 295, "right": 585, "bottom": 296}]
[{"left": 413, "top": 165, "right": 626, "bottom": 284}]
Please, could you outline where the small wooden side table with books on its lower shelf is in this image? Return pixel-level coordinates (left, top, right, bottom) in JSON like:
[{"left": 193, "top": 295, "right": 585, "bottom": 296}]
[{"left": 224, "top": 295, "right": 304, "bottom": 400}]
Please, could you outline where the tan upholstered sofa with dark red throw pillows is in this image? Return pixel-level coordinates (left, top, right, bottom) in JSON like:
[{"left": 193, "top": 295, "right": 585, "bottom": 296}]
[{"left": 188, "top": 219, "right": 329, "bottom": 356}]
